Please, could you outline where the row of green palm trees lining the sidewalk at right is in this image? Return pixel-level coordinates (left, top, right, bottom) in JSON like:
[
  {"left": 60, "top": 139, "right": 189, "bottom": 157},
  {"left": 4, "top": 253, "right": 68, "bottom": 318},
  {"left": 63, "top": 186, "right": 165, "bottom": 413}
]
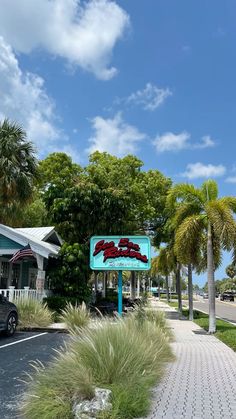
[{"left": 154, "top": 180, "right": 236, "bottom": 333}]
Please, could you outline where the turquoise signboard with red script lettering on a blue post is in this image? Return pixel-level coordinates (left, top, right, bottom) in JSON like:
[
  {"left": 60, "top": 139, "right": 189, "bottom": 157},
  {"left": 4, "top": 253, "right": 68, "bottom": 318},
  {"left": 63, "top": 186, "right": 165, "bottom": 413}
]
[{"left": 90, "top": 236, "right": 151, "bottom": 271}]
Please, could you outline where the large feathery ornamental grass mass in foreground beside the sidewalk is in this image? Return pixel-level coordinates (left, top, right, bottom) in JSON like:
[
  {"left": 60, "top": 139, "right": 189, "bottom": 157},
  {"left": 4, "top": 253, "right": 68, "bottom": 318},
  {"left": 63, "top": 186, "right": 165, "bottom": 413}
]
[{"left": 22, "top": 308, "right": 173, "bottom": 419}]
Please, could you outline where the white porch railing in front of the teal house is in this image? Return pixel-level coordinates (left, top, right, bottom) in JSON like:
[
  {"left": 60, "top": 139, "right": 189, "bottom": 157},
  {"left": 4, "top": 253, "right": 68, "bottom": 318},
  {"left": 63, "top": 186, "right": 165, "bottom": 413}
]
[{"left": 0, "top": 286, "right": 51, "bottom": 301}]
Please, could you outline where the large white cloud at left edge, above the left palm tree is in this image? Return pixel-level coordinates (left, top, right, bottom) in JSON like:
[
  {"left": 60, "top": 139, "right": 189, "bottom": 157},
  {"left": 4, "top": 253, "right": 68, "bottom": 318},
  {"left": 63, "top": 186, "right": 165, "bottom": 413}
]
[{"left": 0, "top": 37, "right": 63, "bottom": 154}]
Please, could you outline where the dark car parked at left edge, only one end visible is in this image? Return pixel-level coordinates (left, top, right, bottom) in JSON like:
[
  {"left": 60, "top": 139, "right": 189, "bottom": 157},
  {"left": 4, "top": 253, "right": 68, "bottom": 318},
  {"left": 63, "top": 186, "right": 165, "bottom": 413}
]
[{"left": 0, "top": 294, "right": 18, "bottom": 336}]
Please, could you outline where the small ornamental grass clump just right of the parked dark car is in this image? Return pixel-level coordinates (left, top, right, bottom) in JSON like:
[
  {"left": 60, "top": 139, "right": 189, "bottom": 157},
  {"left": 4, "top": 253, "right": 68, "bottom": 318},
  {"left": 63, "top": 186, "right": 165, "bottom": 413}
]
[{"left": 14, "top": 298, "right": 53, "bottom": 329}]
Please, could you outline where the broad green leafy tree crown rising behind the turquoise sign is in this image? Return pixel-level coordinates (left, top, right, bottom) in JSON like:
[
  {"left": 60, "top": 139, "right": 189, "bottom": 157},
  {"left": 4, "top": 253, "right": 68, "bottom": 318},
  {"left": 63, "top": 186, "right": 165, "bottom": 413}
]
[{"left": 42, "top": 152, "right": 171, "bottom": 300}]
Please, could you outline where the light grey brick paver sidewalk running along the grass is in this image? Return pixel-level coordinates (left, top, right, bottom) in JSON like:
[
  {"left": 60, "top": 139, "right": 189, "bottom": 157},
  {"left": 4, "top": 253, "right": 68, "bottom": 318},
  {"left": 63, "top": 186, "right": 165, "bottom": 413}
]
[{"left": 148, "top": 302, "right": 236, "bottom": 419}]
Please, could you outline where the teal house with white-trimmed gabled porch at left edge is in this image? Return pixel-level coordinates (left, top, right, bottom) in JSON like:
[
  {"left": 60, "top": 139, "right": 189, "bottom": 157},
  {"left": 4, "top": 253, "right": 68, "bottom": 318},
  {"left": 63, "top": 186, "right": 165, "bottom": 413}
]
[{"left": 0, "top": 224, "right": 62, "bottom": 300}]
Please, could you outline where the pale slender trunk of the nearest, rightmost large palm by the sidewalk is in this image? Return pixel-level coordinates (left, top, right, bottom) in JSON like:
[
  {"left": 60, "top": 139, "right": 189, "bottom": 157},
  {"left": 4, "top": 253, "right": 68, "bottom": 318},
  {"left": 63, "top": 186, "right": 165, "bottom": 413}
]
[{"left": 207, "top": 223, "right": 216, "bottom": 333}]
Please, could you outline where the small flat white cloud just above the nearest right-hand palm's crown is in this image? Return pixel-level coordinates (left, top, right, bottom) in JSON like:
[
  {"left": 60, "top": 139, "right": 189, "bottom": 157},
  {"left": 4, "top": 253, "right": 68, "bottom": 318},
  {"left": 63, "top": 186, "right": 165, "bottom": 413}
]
[{"left": 182, "top": 162, "right": 226, "bottom": 179}]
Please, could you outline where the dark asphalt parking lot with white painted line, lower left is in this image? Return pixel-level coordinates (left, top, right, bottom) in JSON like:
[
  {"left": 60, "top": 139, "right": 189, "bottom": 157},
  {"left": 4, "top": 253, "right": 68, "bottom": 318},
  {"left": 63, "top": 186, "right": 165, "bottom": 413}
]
[{"left": 0, "top": 332, "right": 68, "bottom": 419}]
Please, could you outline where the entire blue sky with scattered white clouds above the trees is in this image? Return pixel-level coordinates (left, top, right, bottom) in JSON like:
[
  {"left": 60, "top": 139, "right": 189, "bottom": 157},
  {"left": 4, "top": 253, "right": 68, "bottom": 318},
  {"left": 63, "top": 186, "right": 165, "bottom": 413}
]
[{"left": 0, "top": 0, "right": 236, "bottom": 284}]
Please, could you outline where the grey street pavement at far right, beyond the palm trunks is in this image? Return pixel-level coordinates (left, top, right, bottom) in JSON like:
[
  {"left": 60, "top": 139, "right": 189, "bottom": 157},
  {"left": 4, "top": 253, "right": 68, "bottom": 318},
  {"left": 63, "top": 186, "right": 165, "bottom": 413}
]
[{"left": 193, "top": 299, "right": 236, "bottom": 324}]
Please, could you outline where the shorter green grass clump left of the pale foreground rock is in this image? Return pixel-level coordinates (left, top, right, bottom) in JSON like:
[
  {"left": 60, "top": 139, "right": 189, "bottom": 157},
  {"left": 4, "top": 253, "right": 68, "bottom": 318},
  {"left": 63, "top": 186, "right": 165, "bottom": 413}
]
[{"left": 20, "top": 351, "right": 94, "bottom": 419}]
